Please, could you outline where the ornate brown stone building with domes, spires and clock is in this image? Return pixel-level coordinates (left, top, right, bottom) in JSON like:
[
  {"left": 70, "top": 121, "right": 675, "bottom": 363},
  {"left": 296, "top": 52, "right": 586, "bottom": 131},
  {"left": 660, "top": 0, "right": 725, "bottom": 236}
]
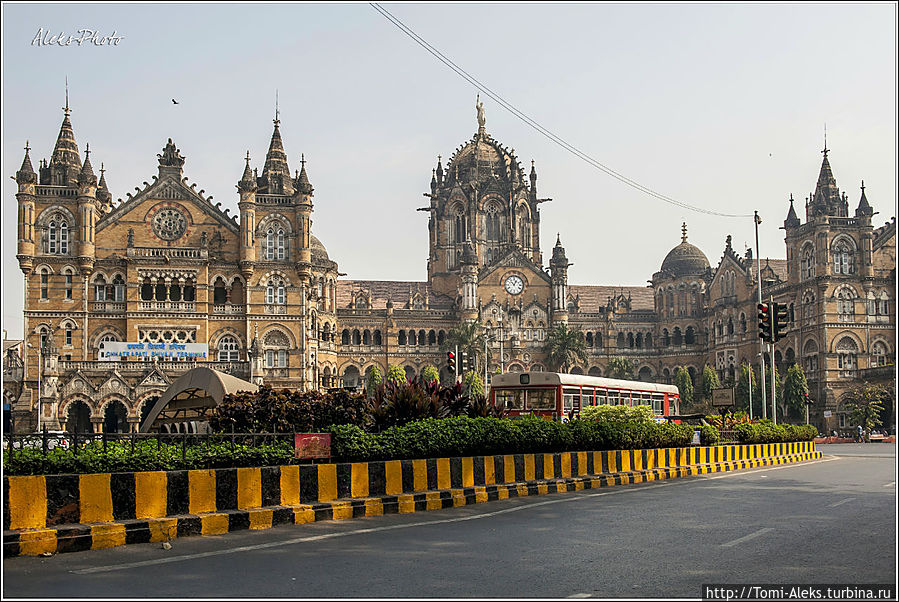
[{"left": 7, "top": 105, "right": 896, "bottom": 431}]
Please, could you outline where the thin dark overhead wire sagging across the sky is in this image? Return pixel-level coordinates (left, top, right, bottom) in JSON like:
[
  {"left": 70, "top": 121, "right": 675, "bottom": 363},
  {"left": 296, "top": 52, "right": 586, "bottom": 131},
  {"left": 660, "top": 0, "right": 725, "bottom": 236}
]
[{"left": 369, "top": 2, "right": 753, "bottom": 218}]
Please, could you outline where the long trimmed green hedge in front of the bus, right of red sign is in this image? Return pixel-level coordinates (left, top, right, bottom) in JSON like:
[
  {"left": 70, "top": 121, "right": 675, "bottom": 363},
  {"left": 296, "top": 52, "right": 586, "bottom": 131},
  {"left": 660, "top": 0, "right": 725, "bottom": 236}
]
[{"left": 331, "top": 416, "right": 693, "bottom": 462}]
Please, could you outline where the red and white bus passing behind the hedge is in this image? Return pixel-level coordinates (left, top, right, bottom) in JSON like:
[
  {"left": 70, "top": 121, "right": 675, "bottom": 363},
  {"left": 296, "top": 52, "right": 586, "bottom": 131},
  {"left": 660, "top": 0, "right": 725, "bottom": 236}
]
[{"left": 490, "top": 372, "right": 680, "bottom": 419}]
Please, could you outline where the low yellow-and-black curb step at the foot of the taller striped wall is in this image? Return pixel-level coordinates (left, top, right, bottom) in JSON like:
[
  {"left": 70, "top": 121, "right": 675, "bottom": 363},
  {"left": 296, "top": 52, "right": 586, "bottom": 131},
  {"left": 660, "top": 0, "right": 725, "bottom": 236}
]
[{"left": 3, "top": 451, "right": 823, "bottom": 558}]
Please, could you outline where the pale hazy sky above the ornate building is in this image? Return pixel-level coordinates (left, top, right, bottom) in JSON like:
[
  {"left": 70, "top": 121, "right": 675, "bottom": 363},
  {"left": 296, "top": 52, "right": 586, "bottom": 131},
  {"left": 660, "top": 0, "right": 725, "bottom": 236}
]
[{"left": 0, "top": 3, "right": 897, "bottom": 338}]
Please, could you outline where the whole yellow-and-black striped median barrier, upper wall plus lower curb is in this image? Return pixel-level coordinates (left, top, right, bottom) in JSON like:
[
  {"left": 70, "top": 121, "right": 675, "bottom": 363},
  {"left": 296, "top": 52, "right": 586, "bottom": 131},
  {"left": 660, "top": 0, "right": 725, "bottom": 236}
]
[{"left": 3, "top": 442, "right": 822, "bottom": 557}]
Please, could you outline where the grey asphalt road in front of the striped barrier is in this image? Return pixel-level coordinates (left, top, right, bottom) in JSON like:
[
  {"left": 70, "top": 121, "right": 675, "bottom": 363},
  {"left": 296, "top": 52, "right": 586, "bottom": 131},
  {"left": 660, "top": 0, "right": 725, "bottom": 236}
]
[{"left": 3, "top": 444, "right": 896, "bottom": 598}]
